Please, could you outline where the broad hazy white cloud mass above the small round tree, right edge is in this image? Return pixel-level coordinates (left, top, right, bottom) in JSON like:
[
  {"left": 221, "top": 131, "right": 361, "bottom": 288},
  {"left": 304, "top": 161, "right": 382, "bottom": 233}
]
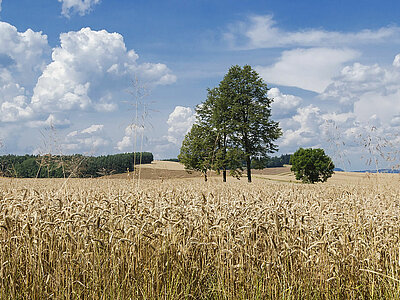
[{"left": 273, "top": 55, "right": 400, "bottom": 169}]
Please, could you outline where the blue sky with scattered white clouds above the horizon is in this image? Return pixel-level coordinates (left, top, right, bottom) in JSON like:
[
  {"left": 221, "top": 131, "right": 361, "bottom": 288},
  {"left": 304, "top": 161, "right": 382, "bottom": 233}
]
[{"left": 0, "top": 0, "right": 400, "bottom": 170}]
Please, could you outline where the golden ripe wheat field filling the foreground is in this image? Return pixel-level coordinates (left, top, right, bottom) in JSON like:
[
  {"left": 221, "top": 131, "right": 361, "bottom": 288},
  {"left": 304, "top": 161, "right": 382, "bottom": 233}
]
[{"left": 0, "top": 174, "right": 400, "bottom": 299}]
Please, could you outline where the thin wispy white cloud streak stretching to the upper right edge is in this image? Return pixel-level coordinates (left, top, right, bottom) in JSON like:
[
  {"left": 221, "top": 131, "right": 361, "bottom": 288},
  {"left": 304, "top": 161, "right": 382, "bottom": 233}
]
[{"left": 225, "top": 15, "right": 400, "bottom": 49}]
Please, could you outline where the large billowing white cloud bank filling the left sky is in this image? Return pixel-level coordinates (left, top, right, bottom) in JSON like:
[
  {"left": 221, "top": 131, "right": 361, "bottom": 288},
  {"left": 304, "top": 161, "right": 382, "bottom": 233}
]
[{"left": 0, "top": 22, "right": 176, "bottom": 153}]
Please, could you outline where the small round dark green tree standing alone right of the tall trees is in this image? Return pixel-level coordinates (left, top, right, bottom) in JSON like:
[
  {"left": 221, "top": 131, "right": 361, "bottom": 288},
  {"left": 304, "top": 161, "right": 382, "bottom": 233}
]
[{"left": 290, "top": 148, "right": 335, "bottom": 183}]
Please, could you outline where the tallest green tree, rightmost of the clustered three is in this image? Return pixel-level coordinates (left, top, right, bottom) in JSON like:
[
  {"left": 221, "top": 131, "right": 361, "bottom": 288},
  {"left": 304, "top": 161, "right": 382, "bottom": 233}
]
[{"left": 218, "top": 65, "right": 282, "bottom": 182}]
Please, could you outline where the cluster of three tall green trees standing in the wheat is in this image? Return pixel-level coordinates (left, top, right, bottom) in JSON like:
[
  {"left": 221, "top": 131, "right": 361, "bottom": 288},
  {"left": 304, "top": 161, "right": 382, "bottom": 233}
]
[{"left": 178, "top": 65, "right": 282, "bottom": 182}]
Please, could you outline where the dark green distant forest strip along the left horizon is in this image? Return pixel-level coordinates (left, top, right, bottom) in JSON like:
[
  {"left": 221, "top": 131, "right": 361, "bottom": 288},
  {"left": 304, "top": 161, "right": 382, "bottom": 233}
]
[{"left": 0, "top": 152, "right": 153, "bottom": 178}]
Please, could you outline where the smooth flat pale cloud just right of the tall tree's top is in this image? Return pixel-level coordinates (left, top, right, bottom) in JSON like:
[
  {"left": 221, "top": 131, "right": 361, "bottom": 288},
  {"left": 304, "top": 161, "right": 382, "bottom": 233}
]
[{"left": 256, "top": 48, "right": 358, "bottom": 93}]
